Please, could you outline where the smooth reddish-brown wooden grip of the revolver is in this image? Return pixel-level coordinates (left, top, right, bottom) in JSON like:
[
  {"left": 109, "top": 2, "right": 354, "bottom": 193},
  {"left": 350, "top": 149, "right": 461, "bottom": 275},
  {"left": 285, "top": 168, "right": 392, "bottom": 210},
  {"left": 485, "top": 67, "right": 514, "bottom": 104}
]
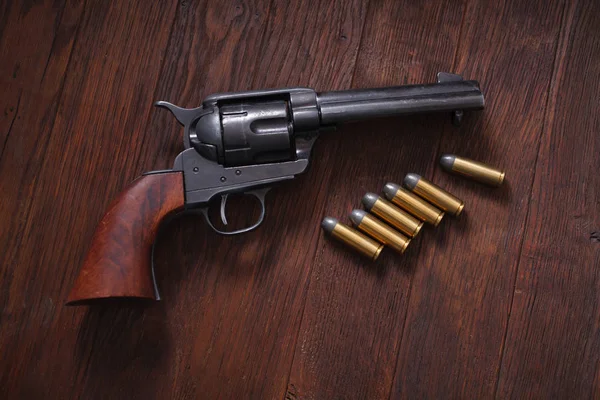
[{"left": 67, "top": 172, "right": 184, "bottom": 305}]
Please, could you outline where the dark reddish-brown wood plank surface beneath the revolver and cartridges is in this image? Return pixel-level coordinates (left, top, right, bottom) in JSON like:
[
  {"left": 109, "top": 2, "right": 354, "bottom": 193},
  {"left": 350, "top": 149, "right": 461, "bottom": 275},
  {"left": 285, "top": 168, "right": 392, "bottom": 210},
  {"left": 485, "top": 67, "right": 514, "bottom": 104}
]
[{"left": 0, "top": 0, "right": 600, "bottom": 399}]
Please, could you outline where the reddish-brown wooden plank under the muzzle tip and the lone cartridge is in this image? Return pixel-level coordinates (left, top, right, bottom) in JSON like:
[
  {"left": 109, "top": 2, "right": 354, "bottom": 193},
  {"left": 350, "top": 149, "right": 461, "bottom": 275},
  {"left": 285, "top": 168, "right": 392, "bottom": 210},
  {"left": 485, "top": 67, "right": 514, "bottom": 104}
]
[{"left": 393, "top": 0, "right": 563, "bottom": 398}]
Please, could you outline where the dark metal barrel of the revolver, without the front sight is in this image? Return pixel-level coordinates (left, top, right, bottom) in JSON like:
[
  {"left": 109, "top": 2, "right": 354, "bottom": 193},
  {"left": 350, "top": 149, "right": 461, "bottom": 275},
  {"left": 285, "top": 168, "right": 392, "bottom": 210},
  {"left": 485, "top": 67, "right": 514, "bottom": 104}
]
[{"left": 317, "top": 81, "right": 484, "bottom": 125}]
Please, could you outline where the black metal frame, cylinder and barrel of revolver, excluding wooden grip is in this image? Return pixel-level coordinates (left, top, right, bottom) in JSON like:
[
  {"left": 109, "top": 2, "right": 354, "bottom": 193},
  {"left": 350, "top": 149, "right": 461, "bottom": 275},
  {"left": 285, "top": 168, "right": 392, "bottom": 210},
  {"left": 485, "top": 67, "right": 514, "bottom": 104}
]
[{"left": 156, "top": 73, "right": 484, "bottom": 234}]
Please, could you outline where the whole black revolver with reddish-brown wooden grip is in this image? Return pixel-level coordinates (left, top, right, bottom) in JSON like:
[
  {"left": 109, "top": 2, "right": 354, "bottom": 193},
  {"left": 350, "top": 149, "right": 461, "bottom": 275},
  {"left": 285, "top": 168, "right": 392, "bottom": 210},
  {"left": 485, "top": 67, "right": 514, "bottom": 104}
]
[{"left": 67, "top": 73, "right": 484, "bottom": 305}]
